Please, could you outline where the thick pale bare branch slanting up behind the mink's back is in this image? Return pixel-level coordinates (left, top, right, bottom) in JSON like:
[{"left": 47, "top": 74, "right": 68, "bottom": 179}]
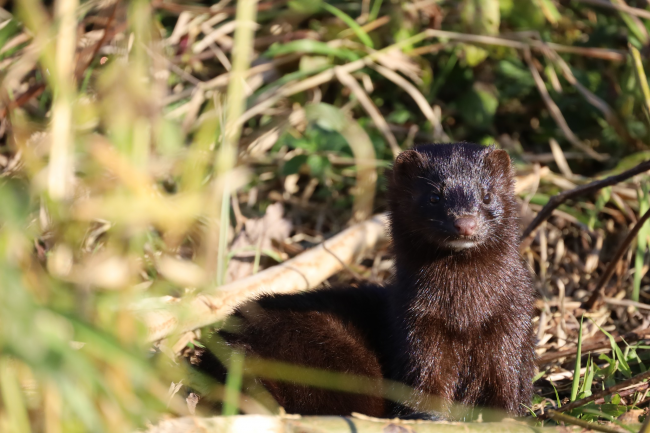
[{"left": 133, "top": 214, "right": 388, "bottom": 341}]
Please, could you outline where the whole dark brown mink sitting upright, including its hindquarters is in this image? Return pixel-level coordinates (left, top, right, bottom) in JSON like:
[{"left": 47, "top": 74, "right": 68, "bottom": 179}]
[{"left": 190, "top": 143, "right": 535, "bottom": 417}]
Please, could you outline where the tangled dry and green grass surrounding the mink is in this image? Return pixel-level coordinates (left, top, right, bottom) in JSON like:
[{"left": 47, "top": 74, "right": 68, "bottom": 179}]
[{"left": 0, "top": 0, "right": 650, "bottom": 432}]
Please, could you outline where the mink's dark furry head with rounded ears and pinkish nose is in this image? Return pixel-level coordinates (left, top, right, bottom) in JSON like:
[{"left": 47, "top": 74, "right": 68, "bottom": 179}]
[{"left": 388, "top": 143, "right": 518, "bottom": 256}]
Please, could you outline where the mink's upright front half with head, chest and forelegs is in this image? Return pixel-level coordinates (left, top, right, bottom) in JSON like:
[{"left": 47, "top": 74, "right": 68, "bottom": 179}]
[{"left": 388, "top": 143, "right": 535, "bottom": 414}]
